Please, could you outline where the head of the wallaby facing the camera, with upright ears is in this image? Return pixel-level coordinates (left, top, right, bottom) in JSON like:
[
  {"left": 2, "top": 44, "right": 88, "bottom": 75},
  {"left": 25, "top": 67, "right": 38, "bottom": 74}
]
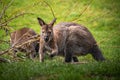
[{"left": 37, "top": 17, "right": 56, "bottom": 42}]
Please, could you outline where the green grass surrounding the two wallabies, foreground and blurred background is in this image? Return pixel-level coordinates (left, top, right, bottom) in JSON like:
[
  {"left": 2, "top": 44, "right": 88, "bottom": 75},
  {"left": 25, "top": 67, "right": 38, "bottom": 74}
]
[{"left": 0, "top": 0, "right": 120, "bottom": 80}]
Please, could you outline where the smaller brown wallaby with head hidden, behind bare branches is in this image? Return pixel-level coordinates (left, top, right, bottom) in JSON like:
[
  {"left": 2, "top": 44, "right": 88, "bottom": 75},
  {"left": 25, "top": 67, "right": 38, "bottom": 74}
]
[{"left": 10, "top": 27, "right": 39, "bottom": 59}]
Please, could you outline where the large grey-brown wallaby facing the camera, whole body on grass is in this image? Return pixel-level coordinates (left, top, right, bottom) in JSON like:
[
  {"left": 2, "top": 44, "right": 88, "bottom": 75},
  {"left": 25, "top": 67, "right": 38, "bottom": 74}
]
[{"left": 37, "top": 18, "right": 105, "bottom": 62}]
